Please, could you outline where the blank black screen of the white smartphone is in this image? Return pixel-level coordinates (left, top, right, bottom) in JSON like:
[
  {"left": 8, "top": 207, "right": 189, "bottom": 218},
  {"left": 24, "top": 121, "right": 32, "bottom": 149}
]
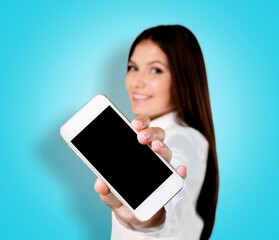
[{"left": 72, "top": 106, "right": 172, "bottom": 209}]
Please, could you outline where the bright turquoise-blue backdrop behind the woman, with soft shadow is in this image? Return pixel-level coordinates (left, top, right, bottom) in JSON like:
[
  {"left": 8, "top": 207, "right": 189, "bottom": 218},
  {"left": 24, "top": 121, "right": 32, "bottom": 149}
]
[{"left": 0, "top": 0, "right": 279, "bottom": 240}]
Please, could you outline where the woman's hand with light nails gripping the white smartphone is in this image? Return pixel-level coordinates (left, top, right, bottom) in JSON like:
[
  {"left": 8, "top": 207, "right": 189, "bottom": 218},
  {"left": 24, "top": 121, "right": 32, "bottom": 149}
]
[{"left": 94, "top": 115, "right": 187, "bottom": 228}]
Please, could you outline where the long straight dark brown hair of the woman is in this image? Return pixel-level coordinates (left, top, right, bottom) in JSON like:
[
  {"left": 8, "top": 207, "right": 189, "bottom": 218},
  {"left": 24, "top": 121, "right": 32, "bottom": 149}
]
[{"left": 129, "top": 25, "right": 219, "bottom": 239}]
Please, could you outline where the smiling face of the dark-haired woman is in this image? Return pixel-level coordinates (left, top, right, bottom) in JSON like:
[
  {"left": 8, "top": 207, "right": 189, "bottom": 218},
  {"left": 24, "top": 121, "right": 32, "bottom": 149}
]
[{"left": 126, "top": 40, "right": 173, "bottom": 119}]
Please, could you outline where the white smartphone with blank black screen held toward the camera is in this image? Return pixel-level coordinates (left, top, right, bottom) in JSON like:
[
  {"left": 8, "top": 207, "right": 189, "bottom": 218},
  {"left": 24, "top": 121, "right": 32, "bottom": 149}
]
[{"left": 60, "top": 94, "right": 184, "bottom": 221}]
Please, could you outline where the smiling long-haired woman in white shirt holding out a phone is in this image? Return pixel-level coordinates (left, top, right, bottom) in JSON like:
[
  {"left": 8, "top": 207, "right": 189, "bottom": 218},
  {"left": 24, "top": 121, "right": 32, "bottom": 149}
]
[{"left": 95, "top": 25, "right": 219, "bottom": 240}]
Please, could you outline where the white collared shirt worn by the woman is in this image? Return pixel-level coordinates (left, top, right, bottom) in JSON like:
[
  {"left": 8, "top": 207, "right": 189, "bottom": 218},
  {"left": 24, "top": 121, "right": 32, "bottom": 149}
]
[{"left": 111, "top": 112, "right": 208, "bottom": 240}]
